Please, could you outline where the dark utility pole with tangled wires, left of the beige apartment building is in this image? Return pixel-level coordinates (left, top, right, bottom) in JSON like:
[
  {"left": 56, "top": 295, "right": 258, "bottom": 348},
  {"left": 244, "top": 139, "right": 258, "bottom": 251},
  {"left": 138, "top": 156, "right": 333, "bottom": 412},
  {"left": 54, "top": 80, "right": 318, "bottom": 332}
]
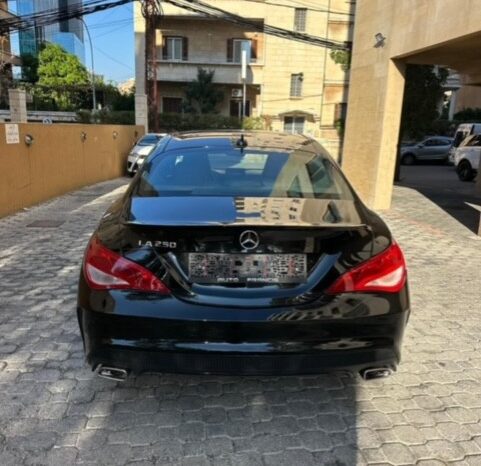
[{"left": 141, "top": 0, "right": 162, "bottom": 132}]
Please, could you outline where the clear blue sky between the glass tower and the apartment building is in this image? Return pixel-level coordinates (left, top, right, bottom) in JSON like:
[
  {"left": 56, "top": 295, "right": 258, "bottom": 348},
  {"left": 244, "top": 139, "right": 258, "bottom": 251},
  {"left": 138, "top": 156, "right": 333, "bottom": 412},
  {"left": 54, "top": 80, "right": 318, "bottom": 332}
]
[{"left": 9, "top": 0, "right": 135, "bottom": 83}]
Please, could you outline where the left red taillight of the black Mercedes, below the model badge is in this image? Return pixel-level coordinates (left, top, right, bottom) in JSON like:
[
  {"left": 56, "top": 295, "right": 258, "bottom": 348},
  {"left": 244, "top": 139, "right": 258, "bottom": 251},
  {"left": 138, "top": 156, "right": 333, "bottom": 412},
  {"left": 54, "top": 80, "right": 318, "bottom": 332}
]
[{"left": 83, "top": 236, "right": 170, "bottom": 294}]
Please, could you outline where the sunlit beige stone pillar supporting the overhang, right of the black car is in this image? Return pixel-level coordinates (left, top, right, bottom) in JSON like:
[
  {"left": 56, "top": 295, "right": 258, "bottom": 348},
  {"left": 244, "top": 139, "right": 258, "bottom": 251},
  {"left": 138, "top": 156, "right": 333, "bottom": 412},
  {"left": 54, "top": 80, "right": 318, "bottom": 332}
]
[{"left": 342, "top": 60, "right": 404, "bottom": 210}]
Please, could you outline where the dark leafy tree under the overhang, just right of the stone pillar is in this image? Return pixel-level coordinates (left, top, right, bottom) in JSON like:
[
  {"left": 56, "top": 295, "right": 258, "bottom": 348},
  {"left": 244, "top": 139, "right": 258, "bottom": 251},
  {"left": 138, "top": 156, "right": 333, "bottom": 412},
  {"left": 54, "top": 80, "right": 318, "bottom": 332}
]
[{"left": 401, "top": 65, "right": 448, "bottom": 139}]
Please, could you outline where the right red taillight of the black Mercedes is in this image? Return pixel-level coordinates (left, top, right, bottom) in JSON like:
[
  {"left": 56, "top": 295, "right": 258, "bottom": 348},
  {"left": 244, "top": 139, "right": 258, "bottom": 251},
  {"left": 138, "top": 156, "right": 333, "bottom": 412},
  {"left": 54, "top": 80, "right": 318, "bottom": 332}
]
[{"left": 327, "top": 243, "right": 407, "bottom": 294}]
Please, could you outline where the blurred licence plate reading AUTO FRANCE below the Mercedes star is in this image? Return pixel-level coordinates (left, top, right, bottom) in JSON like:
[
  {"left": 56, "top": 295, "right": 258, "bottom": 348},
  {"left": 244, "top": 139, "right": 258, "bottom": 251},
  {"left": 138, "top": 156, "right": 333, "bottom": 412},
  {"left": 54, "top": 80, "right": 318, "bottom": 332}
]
[{"left": 189, "top": 253, "right": 307, "bottom": 283}]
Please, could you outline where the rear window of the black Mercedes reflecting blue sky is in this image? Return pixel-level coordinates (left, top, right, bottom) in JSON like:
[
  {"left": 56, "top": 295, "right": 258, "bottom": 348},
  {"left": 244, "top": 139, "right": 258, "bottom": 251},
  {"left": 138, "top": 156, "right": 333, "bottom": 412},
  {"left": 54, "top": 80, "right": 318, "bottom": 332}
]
[{"left": 134, "top": 147, "right": 353, "bottom": 200}]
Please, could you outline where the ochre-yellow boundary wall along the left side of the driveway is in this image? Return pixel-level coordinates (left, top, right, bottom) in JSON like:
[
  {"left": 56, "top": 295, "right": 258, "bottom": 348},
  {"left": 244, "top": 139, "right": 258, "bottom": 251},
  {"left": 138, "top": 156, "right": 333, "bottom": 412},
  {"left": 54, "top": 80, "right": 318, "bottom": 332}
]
[{"left": 0, "top": 123, "right": 144, "bottom": 217}]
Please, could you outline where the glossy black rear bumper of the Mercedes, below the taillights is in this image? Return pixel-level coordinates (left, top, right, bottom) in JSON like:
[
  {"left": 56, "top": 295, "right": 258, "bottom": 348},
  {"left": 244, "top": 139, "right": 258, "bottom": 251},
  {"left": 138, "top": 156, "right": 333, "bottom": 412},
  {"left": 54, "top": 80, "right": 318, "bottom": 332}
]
[{"left": 78, "top": 290, "right": 409, "bottom": 375}]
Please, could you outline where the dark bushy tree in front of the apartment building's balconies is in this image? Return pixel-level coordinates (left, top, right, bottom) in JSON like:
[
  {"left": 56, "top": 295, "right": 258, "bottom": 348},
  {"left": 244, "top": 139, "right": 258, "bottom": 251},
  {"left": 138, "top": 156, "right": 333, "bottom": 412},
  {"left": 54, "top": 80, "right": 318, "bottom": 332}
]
[{"left": 184, "top": 68, "right": 224, "bottom": 113}]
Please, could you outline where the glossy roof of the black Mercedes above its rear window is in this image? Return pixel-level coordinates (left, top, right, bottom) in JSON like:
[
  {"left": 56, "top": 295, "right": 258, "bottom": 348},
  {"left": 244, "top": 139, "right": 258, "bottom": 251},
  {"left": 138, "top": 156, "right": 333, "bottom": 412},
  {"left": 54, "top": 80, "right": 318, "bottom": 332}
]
[{"left": 161, "top": 130, "right": 325, "bottom": 154}]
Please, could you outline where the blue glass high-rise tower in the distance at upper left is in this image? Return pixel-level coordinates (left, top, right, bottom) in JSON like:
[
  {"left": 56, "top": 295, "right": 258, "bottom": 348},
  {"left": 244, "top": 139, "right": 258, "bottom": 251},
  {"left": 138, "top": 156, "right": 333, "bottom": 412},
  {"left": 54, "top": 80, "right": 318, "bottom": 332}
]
[{"left": 17, "top": 0, "right": 85, "bottom": 63}]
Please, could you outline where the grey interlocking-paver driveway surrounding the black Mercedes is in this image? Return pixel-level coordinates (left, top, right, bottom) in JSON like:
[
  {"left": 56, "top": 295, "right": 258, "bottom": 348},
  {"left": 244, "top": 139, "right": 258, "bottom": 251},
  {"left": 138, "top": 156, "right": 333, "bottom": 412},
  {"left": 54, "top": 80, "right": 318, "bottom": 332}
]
[{"left": 0, "top": 179, "right": 481, "bottom": 466}]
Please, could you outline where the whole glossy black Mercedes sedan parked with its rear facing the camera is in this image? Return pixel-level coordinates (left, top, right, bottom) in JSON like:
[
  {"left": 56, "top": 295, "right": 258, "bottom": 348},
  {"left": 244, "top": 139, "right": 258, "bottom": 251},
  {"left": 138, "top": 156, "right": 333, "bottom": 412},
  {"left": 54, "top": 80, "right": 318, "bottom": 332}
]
[{"left": 77, "top": 131, "right": 410, "bottom": 380}]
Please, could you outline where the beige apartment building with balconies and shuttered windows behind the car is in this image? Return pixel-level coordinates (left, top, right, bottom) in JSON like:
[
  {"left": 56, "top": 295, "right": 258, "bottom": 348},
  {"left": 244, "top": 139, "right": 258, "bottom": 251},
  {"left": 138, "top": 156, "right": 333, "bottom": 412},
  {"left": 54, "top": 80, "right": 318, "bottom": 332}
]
[{"left": 135, "top": 0, "right": 353, "bottom": 155}]
